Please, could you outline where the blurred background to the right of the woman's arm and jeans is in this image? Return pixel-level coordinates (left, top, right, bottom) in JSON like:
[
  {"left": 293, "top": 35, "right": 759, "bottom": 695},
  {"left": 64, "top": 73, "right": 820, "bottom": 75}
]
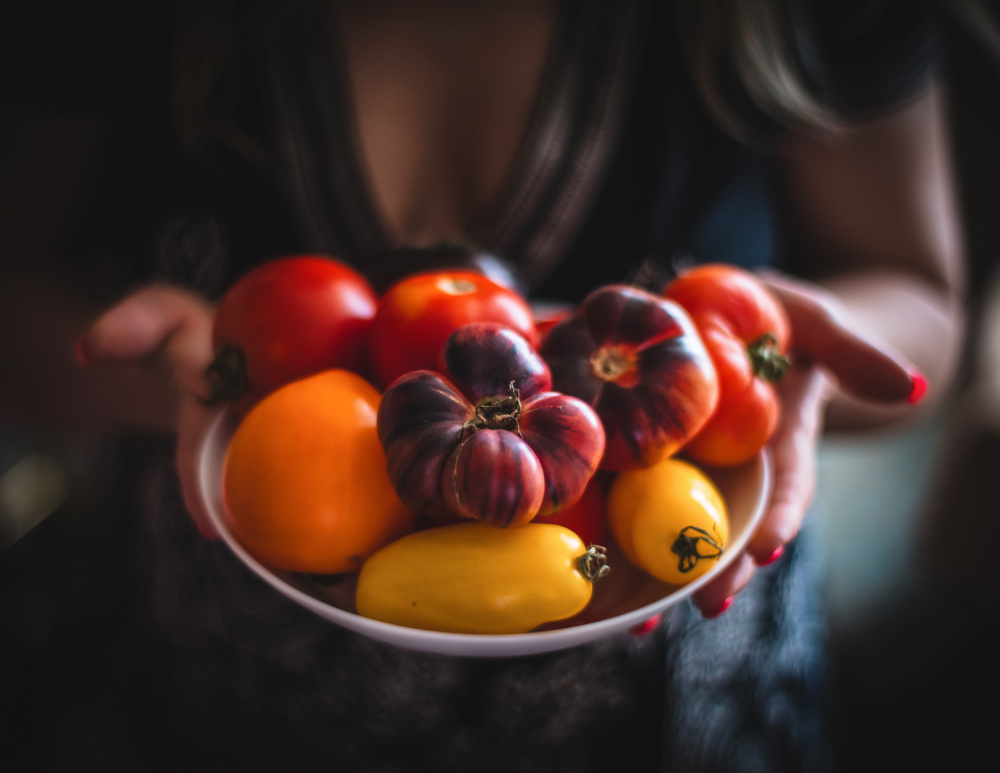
[{"left": 816, "top": 0, "right": 1000, "bottom": 771}]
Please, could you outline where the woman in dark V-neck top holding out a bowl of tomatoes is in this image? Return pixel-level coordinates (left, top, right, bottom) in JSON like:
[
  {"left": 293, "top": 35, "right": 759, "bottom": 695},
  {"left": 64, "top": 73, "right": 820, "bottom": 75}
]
[{"left": 2, "top": 0, "right": 962, "bottom": 770}]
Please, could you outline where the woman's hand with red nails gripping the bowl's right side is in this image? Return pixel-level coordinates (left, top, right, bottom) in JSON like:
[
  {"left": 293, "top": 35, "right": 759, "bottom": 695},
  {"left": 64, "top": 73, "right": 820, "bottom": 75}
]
[{"left": 694, "top": 273, "right": 926, "bottom": 617}]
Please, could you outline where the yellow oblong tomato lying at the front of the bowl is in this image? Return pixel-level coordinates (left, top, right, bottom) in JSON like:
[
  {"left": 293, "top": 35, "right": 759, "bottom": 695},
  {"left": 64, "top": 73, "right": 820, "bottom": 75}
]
[{"left": 356, "top": 521, "right": 607, "bottom": 634}]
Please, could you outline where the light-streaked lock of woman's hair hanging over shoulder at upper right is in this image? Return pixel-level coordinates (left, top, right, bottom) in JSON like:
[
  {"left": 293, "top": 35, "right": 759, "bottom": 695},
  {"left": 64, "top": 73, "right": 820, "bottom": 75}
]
[{"left": 676, "top": 0, "right": 840, "bottom": 141}]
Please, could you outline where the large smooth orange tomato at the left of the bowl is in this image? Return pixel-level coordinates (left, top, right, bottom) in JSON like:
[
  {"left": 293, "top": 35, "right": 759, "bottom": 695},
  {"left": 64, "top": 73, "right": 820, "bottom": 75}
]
[{"left": 223, "top": 370, "right": 416, "bottom": 574}]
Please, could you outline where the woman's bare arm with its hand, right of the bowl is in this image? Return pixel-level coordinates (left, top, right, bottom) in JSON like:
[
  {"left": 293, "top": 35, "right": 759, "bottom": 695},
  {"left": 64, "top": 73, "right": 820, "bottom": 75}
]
[{"left": 695, "top": 84, "right": 965, "bottom": 614}]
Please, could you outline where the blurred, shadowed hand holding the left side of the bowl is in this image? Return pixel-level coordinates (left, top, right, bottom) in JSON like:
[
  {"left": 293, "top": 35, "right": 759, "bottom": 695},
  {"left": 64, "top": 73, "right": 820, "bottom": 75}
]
[{"left": 76, "top": 285, "right": 218, "bottom": 537}]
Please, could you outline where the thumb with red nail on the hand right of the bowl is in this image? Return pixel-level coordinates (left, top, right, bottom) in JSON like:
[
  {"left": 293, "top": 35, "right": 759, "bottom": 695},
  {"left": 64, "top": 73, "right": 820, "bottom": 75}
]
[{"left": 761, "top": 272, "right": 926, "bottom": 402}]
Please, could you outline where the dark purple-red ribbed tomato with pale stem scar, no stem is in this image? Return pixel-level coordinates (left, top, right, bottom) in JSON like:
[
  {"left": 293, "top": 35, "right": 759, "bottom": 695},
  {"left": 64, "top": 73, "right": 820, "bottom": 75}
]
[{"left": 540, "top": 285, "right": 719, "bottom": 470}]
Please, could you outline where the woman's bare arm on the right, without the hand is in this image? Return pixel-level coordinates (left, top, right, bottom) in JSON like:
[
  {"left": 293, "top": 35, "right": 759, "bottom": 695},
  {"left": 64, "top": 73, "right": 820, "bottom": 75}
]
[{"left": 781, "top": 88, "right": 965, "bottom": 429}]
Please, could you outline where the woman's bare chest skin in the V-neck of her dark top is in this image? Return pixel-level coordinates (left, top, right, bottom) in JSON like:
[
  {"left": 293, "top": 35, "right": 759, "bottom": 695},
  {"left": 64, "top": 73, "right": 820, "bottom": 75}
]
[{"left": 333, "top": 0, "right": 558, "bottom": 246}]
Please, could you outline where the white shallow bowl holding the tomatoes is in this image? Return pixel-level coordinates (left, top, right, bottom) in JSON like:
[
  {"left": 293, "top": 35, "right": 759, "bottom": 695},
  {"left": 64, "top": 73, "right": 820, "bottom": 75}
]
[{"left": 198, "top": 412, "right": 772, "bottom": 657}]
